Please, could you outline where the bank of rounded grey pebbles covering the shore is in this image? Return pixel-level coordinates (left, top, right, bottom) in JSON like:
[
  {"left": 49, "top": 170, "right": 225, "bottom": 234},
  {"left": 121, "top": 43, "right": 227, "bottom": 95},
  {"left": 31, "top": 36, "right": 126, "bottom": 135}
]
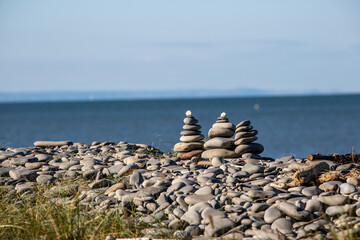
[{"left": 0, "top": 141, "right": 360, "bottom": 240}]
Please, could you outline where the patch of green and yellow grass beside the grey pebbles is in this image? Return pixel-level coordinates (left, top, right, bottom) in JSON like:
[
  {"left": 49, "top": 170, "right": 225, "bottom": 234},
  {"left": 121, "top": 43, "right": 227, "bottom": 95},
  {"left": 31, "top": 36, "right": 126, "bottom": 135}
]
[{"left": 0, "top": 180, "right": 171, "bottom": 239}]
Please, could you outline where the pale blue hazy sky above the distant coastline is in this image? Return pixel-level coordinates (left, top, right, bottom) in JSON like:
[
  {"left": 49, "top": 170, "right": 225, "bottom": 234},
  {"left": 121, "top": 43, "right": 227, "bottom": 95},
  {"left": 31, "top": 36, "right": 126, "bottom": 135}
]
[{"left": 0, "top": 0, "right": 360, "bottom": 92}]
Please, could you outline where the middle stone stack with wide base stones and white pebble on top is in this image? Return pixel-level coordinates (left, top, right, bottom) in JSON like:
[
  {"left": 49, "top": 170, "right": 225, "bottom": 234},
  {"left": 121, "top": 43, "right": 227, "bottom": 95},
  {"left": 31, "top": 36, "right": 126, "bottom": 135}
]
[{"left": 201, "top": 113, "right": 237, "bottom": 159}]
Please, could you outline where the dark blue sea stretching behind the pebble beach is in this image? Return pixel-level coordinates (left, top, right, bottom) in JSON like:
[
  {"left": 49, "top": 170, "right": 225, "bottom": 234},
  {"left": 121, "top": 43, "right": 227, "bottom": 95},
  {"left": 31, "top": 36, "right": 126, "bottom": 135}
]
[{"left": 0, "top": 95, "right": 360, "bottom": 157}]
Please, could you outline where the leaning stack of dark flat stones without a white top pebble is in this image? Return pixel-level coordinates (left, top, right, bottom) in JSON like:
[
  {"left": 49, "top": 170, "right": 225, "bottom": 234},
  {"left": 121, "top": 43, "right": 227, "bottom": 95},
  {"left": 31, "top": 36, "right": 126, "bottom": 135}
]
[{"left": 234, "top": 120, "right": 264, "bottom": 158}]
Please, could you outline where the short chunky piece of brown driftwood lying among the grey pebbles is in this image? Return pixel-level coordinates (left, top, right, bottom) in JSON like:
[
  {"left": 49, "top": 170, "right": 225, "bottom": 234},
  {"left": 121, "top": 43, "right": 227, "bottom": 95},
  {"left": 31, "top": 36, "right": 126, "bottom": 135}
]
[{"left": 293, "top": 162, "right": 329, "bottom": 186}]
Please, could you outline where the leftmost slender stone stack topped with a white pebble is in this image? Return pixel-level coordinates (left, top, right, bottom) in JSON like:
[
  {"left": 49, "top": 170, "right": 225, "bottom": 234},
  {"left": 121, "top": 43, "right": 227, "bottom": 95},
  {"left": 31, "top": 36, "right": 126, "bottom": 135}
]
[{"left": 174, "top": 110, "right": 204, "bottom": 159}]
